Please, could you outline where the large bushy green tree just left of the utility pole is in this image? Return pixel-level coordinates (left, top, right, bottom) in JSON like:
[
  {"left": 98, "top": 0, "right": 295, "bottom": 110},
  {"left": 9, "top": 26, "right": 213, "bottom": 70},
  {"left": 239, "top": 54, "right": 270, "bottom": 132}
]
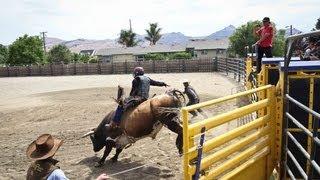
[{"left": 7, "top": 35, "right": 45, "bottom": 66}]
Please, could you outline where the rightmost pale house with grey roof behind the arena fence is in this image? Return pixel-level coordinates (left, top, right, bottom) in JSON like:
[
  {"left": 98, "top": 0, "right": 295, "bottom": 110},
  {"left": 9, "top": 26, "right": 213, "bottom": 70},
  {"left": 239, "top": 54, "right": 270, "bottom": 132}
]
[{"left": 186, "top": 39, "right": 229, "bottom": 59}]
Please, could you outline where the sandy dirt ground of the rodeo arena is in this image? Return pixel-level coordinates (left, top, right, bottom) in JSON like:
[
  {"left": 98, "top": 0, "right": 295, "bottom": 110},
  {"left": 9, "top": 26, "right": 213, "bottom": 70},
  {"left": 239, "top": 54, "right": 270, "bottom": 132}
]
[{"left": 0, "top": 73, "right": 237, "bottom": 180}]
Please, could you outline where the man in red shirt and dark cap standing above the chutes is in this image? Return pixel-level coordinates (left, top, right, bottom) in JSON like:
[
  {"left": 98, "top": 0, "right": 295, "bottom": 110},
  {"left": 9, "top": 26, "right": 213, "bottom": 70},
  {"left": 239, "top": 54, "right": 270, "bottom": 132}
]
[{"left": 254, "top": 17, "right": 273, "bottom": 73}]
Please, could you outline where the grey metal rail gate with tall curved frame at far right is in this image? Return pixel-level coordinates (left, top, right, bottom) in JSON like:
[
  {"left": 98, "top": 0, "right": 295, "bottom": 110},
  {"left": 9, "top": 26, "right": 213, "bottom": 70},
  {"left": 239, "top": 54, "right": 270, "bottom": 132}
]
[{"left": 280, "top": 30, "right": 320, "bottom": 179}]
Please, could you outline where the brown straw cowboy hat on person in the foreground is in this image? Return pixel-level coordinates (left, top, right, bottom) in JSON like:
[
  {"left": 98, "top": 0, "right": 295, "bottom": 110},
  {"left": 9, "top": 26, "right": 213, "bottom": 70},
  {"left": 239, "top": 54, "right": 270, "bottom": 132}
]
[{"left": 26, "top": 134, "right": 63, "bottom": 160}]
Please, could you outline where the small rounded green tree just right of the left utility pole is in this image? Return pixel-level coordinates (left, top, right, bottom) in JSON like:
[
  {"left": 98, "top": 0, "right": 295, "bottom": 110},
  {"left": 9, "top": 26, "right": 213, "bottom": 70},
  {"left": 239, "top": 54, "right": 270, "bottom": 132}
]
[{"left": 48, "top": 44, "right": 72, "bottom": 64}]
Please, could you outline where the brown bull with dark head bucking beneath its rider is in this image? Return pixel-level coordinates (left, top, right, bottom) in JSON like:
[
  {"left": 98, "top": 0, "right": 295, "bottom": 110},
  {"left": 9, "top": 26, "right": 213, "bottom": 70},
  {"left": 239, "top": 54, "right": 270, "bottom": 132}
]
[{"left": 83, "top": 90, "right": 185, "bottom": 166}]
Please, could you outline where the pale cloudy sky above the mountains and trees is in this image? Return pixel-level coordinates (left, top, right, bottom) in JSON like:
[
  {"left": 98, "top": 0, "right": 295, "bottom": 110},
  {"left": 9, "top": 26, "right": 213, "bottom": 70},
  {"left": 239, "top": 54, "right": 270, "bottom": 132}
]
[{"left": 0, "top": 0, "right": 320, "bottom": 45}]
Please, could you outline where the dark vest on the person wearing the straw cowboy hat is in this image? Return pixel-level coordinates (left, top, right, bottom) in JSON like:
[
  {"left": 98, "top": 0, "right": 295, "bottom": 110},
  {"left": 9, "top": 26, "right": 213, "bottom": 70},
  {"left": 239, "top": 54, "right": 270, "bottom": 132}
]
[{"left": 26, "top": 160, "right": 59, "bottom": 180}]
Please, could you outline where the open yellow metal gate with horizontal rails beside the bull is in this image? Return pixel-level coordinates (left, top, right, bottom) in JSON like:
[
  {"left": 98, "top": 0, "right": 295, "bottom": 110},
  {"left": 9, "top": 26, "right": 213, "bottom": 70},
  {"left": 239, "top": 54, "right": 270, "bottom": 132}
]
[{"left": 181, "top": 85, "right": 276, "bottom": 180}]
